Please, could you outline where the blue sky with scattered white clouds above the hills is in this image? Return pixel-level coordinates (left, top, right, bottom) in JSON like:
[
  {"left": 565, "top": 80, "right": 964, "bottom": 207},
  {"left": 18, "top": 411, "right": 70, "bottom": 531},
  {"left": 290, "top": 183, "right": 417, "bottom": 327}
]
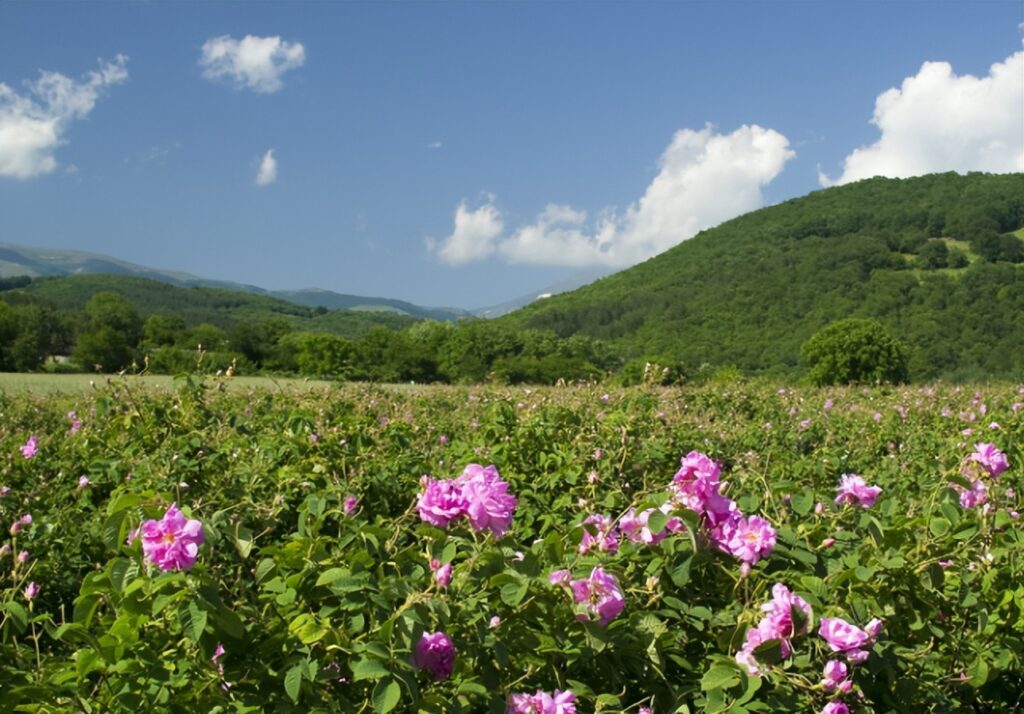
[{"left": 0, "top": 0, "right": 1024, "bottom": 307}]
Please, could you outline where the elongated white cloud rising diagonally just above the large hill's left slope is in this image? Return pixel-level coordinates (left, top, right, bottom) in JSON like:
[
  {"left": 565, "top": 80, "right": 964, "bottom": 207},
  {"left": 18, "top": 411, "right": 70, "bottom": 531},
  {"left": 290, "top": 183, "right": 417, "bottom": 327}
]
[{"left": 432, "top": 125, "right": 795, "bottom": 268}]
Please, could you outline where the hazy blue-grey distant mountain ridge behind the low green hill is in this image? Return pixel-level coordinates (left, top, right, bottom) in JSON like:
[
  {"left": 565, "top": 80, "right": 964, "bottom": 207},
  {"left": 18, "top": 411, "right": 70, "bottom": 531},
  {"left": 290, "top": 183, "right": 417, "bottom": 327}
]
[{"left": 0, "top": 243, "right": 471, "bottom": 322}]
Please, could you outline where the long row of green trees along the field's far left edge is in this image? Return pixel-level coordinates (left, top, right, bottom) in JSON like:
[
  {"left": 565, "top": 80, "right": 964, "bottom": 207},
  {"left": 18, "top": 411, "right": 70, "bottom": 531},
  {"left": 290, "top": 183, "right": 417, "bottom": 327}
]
[{"left": 0, "top": 286, "right": 622, "bottom": 383}]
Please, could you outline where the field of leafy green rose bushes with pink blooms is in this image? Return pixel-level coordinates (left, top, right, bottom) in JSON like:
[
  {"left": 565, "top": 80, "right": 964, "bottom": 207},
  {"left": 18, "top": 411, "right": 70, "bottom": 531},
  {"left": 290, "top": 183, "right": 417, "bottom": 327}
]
[{"left": 0, "top": 377, "right": 1024, "bottom": 714}]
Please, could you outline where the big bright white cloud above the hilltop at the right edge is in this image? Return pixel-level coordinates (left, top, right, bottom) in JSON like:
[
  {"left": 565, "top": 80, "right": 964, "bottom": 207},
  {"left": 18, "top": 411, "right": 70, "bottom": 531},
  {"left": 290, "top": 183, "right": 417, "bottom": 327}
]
[{"left": 819, "top": 52, "right": 1024, "bottom": 185}]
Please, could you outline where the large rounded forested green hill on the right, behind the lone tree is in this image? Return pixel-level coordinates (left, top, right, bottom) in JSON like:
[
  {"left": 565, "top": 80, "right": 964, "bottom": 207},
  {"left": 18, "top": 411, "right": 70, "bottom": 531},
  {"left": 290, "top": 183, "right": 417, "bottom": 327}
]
[{"left": 502, "top": 173, "right": 1024, "bottom": 379}]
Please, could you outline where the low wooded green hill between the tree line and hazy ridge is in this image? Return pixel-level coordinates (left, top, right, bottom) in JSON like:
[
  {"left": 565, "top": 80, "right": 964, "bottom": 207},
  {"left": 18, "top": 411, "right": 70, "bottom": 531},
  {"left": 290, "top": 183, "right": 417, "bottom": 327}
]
[{"left": 6, "top": 275, "right": 417, "bottom": 338}]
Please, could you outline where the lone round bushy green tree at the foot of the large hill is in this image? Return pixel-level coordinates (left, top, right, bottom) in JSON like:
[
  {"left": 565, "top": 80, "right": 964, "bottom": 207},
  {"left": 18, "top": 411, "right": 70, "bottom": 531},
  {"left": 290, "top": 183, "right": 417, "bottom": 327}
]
[{"left": 800, "top": 318, "right": 908, "bottom": 385}]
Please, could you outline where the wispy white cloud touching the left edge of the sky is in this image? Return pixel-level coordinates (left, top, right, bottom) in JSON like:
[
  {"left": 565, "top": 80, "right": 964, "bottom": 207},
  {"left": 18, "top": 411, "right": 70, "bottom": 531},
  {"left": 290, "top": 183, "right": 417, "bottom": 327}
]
[{"left": 0, "top": 54, "right": 128, "bottom": 179}]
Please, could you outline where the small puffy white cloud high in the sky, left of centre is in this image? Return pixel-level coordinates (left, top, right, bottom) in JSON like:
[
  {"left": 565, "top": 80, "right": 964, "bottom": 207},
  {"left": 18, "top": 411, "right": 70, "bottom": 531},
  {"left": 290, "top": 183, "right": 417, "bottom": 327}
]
[{"left": 199, "top": 35, "right": 306, "bottom": 94}]
